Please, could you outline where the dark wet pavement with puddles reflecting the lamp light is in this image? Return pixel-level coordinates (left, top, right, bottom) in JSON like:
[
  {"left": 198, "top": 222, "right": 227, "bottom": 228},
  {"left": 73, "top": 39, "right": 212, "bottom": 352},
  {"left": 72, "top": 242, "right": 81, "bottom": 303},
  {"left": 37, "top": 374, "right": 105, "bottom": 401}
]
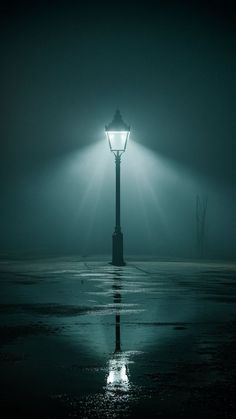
[{"left": 0, "top": 258, "right": 236, "bottom": 419}]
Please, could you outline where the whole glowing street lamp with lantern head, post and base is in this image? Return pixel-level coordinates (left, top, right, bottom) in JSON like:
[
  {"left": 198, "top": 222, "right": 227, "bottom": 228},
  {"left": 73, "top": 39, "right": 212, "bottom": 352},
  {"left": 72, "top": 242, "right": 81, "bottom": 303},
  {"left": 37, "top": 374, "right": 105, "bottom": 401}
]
[{"left": 105, "top": 110, "right": 130, "bottom": 266}]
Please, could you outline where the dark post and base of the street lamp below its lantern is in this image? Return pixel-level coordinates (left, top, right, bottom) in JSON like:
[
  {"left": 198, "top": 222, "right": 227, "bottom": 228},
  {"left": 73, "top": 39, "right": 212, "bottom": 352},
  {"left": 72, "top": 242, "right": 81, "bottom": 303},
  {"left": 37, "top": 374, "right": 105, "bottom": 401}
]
[{"left": 112, "top": 152, "right": 125, "bottom": 266}]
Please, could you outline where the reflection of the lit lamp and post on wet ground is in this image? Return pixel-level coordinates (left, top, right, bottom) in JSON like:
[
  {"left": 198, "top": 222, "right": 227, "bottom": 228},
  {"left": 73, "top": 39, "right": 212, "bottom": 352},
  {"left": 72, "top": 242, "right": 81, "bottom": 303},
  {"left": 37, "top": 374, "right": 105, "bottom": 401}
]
[{"left": 107, "top": 278, "right": 129, "bottom": 390}]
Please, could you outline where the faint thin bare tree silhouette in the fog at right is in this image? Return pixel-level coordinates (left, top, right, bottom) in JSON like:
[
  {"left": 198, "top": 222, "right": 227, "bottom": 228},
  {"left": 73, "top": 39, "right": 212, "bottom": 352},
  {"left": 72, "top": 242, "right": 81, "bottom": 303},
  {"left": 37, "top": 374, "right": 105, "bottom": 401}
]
[{"left": 196, "top": 195, "right": 208, "bottom": 258}]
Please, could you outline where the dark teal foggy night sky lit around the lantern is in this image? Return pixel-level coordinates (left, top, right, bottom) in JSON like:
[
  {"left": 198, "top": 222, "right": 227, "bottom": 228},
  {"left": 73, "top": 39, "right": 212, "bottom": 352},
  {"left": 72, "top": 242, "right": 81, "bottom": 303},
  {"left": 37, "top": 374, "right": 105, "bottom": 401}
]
[{"left": 0, "top": 0, "right": 236, "bottom": 259}]
